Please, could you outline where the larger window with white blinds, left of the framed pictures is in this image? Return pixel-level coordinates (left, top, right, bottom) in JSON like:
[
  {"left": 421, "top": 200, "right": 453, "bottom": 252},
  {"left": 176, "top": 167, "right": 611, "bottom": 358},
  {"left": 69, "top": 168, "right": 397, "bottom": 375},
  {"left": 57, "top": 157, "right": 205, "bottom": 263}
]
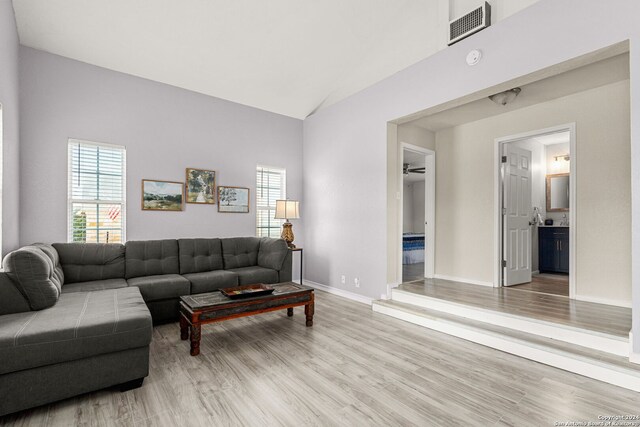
[{"left": 68, "top": 139, "right": 126, "bottom": 243}]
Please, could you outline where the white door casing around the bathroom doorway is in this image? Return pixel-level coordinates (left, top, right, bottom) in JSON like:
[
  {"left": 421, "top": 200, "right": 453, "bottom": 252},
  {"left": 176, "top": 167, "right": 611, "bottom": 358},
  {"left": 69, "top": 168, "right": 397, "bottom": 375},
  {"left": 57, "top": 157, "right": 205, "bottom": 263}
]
[{"left": 493, "top": 122, "right": 578, "bottom": 298}]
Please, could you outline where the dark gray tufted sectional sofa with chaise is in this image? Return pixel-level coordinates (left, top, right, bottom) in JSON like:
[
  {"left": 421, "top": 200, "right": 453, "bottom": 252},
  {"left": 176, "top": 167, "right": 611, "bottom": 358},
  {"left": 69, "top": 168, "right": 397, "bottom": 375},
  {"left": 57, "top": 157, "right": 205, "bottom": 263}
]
[{"left": 0, "top": 237, "right": 291, "bottom": 416}]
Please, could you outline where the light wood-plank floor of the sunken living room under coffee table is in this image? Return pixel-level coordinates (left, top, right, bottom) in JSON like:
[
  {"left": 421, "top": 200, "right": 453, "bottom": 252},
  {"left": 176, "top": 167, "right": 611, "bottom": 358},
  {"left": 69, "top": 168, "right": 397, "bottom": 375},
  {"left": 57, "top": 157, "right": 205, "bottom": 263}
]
[{"left": 0, "top": 292, "right": 640, "bottom": 426}]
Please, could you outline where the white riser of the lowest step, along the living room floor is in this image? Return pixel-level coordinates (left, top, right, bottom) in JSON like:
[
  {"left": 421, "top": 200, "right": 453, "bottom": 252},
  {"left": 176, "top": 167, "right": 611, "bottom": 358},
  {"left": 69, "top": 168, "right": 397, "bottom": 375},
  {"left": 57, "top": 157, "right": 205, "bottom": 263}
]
[{"left": 372, "top": 302, "right": 640, "bottom": 391}]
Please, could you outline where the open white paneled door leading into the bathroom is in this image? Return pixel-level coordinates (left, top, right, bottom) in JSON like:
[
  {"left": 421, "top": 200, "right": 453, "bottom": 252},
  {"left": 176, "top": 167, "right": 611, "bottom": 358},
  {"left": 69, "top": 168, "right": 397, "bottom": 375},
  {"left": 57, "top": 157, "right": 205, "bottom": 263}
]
[{"left": 502, "top": 144, "right": 532, "bottom": 286}]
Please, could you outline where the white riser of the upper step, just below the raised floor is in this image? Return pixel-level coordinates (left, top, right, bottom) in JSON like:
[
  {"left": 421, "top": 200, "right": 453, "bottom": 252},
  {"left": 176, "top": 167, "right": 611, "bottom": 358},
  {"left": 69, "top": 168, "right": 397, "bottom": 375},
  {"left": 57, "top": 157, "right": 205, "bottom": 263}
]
[{"left": 392, "top": 289, "right": 629, "bottom": 357}]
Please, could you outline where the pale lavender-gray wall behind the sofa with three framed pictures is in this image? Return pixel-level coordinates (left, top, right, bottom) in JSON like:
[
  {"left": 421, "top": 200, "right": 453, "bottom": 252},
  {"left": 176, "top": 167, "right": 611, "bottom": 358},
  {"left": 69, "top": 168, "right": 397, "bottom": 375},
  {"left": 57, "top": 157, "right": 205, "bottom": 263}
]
[{"left": 20, "top": 47, "right": 304, "bottom": 244}]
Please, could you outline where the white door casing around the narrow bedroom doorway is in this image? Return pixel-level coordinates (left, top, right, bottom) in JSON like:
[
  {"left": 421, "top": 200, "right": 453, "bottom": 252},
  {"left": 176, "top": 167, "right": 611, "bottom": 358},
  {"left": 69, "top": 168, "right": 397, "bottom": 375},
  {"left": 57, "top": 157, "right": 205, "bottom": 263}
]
[{"left": 396, "top": 142, "right": 436, "bottom": 283}]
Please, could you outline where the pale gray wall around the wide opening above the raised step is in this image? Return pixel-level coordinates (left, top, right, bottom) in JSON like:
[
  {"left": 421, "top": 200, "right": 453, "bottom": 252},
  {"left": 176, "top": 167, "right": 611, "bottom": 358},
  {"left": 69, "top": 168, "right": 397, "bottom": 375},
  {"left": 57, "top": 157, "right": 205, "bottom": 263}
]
[{"left": 304, "top": 0, "right": 640, "bottom": 353}]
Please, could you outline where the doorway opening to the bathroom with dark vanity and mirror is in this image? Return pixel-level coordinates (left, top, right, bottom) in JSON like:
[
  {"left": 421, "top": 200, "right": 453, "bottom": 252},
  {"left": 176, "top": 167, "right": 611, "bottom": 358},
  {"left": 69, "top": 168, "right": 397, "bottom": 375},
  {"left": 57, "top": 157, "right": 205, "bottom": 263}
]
[{"left": 494, "top": 124, "right": 576, "bottom": 298}]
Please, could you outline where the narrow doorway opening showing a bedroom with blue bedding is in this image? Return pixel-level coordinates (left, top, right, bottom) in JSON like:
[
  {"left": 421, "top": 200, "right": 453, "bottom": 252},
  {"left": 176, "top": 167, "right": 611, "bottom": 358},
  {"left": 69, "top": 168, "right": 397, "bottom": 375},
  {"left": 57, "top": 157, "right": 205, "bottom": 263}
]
[{"left": 399, "top": 143, "right": 435, "bottom": 283}]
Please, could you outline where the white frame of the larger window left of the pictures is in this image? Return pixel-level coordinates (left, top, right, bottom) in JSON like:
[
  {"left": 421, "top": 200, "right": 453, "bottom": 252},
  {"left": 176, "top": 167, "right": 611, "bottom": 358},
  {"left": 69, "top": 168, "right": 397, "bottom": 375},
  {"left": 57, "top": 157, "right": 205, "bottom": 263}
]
[{"left": 67, "top": 138, "right": 127, "bottom": 244}]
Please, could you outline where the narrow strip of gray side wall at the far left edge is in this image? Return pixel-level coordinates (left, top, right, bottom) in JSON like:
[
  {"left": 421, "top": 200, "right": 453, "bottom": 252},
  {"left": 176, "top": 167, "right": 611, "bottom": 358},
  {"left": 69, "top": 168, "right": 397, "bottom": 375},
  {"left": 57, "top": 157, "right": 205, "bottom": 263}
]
[{"left": 0, "top": 0, "right": 20, "bottom": 254}]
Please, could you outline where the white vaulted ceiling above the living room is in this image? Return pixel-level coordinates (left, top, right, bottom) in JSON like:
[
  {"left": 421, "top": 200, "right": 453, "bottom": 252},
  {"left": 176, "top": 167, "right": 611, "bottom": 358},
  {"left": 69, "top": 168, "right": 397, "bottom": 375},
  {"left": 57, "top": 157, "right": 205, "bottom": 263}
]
[{"left": 13, "top": 0, "right": 535, "bottom": 118}]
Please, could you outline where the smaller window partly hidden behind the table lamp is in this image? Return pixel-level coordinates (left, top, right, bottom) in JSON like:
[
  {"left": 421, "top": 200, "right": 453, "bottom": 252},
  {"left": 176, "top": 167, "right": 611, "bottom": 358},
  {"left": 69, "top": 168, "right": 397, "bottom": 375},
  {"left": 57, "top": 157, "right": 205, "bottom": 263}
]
[{"left": 256, "top": 166, "right": 287, "bottom": 237}]
